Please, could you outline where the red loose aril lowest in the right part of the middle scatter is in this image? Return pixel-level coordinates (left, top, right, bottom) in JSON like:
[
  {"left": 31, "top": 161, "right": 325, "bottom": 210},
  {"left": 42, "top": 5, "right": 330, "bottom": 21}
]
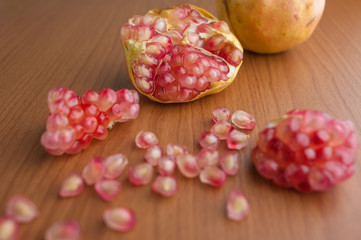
[{"left": 199, "top": 166, "right": 227, "bottom": 187}]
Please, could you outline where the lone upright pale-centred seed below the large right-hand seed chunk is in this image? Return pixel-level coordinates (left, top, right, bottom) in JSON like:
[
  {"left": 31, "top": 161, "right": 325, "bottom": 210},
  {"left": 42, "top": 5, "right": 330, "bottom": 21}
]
[{"left": 227, "top": 190, "right": 250, "bottom": 221}]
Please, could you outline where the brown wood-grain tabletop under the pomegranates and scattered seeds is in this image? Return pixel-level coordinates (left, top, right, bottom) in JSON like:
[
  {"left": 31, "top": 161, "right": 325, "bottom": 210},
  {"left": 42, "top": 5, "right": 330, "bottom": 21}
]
[{"left": 0, "top": 0, "right": 361, "bottom": 240}]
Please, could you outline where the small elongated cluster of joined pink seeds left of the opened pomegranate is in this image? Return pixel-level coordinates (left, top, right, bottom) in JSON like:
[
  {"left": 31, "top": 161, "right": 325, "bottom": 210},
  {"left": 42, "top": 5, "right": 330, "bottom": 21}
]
[{"left": 41, "top": 87, "right": 139, "bottom": 155}]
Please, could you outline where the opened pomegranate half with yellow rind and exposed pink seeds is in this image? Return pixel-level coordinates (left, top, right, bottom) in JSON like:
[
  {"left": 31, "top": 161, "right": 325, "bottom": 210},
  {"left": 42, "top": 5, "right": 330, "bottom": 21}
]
[{"left": 120, "top": 4, "right": 243, "bottom": 103}]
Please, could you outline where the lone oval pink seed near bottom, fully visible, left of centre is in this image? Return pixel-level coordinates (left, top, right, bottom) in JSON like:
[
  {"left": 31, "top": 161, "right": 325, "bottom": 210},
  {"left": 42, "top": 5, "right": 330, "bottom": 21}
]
[{"left": 103, "top": 207, "right": 137, "bottom": 232}]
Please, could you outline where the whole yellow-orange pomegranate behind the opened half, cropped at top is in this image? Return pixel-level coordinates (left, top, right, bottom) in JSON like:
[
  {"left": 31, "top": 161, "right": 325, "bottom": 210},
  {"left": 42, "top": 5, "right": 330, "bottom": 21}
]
[{"left": 217, "top": 0, "right": 325, "bottom": 53}]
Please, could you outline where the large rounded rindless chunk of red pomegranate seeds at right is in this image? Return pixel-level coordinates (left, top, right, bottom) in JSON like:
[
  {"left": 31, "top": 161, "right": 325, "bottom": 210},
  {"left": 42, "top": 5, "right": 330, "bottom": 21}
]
[{"left": 252, "top": 110, "right": 358, "bottom": 192}]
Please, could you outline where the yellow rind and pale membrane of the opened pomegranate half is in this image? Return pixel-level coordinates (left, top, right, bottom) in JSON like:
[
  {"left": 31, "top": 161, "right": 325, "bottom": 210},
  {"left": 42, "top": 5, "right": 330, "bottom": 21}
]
[{"left": 121, "top": 4, "right": 244, "bottom": 103}]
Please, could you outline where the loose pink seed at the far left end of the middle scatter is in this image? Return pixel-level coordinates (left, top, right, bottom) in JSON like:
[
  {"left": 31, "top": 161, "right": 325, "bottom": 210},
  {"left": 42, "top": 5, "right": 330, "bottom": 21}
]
[{"left": 59, "top": 173, "right": 84, "bottom": 197}]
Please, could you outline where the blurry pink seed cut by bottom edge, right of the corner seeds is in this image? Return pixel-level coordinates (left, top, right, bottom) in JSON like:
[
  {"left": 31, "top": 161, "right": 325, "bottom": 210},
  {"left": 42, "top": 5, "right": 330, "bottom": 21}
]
[{"left": 45, "top": 221, "right": 80, "bottom": 240}]
